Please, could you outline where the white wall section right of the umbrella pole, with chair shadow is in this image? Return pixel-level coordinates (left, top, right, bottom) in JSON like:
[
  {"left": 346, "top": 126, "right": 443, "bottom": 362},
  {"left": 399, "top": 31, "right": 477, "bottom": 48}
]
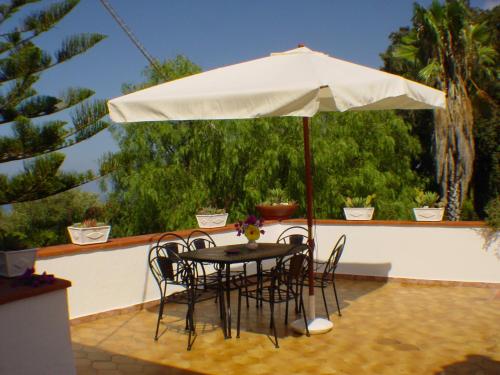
[{"left": 310, "top": 225, "right": 500, "bottom": 283}]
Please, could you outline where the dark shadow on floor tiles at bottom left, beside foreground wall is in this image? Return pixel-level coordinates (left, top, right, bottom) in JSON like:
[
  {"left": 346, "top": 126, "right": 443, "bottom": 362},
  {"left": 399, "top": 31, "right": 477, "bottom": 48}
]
[{"left": 73, "top": 343, "right": 203, "bottom": 375}]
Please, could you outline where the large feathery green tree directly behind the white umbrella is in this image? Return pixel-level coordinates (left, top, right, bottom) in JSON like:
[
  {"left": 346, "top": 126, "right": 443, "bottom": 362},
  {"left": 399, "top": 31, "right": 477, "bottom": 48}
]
[{"left": 105, "top": 57, "right": 423, "bottom": 236}]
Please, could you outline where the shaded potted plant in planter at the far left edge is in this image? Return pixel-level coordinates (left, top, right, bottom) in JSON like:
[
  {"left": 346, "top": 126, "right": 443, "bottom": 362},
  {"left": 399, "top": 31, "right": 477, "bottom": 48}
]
[{"left": 0, "top": 228, "right": 36, "bottom": 277}]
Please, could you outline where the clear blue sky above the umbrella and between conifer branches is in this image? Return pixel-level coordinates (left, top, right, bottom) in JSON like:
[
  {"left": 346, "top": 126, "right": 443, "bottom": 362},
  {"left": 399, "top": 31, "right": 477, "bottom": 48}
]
[{"left": 0, "top": 0, "right": 500, "bottom": 190}]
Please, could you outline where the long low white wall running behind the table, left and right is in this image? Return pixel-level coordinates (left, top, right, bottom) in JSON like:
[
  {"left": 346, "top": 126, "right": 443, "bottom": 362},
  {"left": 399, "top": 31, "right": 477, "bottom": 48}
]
[{"left": 36, "top": 224, "right": 500, "bottom": 318}]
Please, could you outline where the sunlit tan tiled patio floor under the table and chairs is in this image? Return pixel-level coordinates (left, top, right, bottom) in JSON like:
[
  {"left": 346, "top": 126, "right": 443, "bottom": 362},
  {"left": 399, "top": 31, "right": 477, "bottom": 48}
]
[{"left": 71, "top": 279, "right": 500, "bottom": 375}]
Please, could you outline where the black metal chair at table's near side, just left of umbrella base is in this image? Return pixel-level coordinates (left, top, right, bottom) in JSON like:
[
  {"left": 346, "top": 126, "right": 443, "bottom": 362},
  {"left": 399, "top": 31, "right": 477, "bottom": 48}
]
[{"left": 236, "top": 248, "right": 309, "bottom": 348}]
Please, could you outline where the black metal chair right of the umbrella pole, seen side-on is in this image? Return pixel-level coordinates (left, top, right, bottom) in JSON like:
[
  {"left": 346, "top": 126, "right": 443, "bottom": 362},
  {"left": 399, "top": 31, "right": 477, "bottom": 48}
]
[{"left": 303, "top": 234, "right": 347, "bottom": 319}]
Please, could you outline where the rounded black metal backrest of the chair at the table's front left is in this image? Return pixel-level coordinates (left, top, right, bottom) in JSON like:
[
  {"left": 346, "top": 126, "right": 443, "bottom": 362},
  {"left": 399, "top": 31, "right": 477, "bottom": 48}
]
[{"left": 148, "top": 243, "right": 194, "bottom": 290}]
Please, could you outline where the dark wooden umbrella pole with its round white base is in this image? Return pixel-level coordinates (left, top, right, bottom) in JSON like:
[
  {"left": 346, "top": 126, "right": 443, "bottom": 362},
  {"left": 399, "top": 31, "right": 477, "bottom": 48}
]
[{"left": 291, "top": 117, "right": 333, "bottom": 334}]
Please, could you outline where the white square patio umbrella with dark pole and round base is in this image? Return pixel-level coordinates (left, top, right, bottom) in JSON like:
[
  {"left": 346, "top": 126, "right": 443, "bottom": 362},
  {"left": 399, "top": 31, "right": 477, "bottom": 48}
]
[{"left": 108, "top": 46, "right": 446, "bottom": 333}]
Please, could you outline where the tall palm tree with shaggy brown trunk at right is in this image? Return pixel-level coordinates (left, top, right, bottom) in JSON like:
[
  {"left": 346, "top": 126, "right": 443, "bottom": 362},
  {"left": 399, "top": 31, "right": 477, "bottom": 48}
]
[{"left": 385, "top": 0, "right": 498, "bottom": 220}]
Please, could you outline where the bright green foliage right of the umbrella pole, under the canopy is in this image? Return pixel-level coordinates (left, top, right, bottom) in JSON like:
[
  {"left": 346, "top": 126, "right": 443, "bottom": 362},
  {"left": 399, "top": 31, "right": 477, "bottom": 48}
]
[{"left": 312, "top": 111, "right": 423, "bottom": 219}]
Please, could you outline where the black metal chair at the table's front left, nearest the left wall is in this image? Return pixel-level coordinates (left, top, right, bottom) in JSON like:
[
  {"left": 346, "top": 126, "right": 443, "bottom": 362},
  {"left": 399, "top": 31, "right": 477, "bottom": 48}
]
[{"left": 148, "top": 242, "right": 215, "bottom": 350}]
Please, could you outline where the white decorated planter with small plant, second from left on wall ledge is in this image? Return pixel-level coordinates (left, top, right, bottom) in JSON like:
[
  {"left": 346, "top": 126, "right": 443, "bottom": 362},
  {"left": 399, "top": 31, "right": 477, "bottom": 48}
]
[{"left": 68, "top": 206, "right": 111, "bottom": 245}]
